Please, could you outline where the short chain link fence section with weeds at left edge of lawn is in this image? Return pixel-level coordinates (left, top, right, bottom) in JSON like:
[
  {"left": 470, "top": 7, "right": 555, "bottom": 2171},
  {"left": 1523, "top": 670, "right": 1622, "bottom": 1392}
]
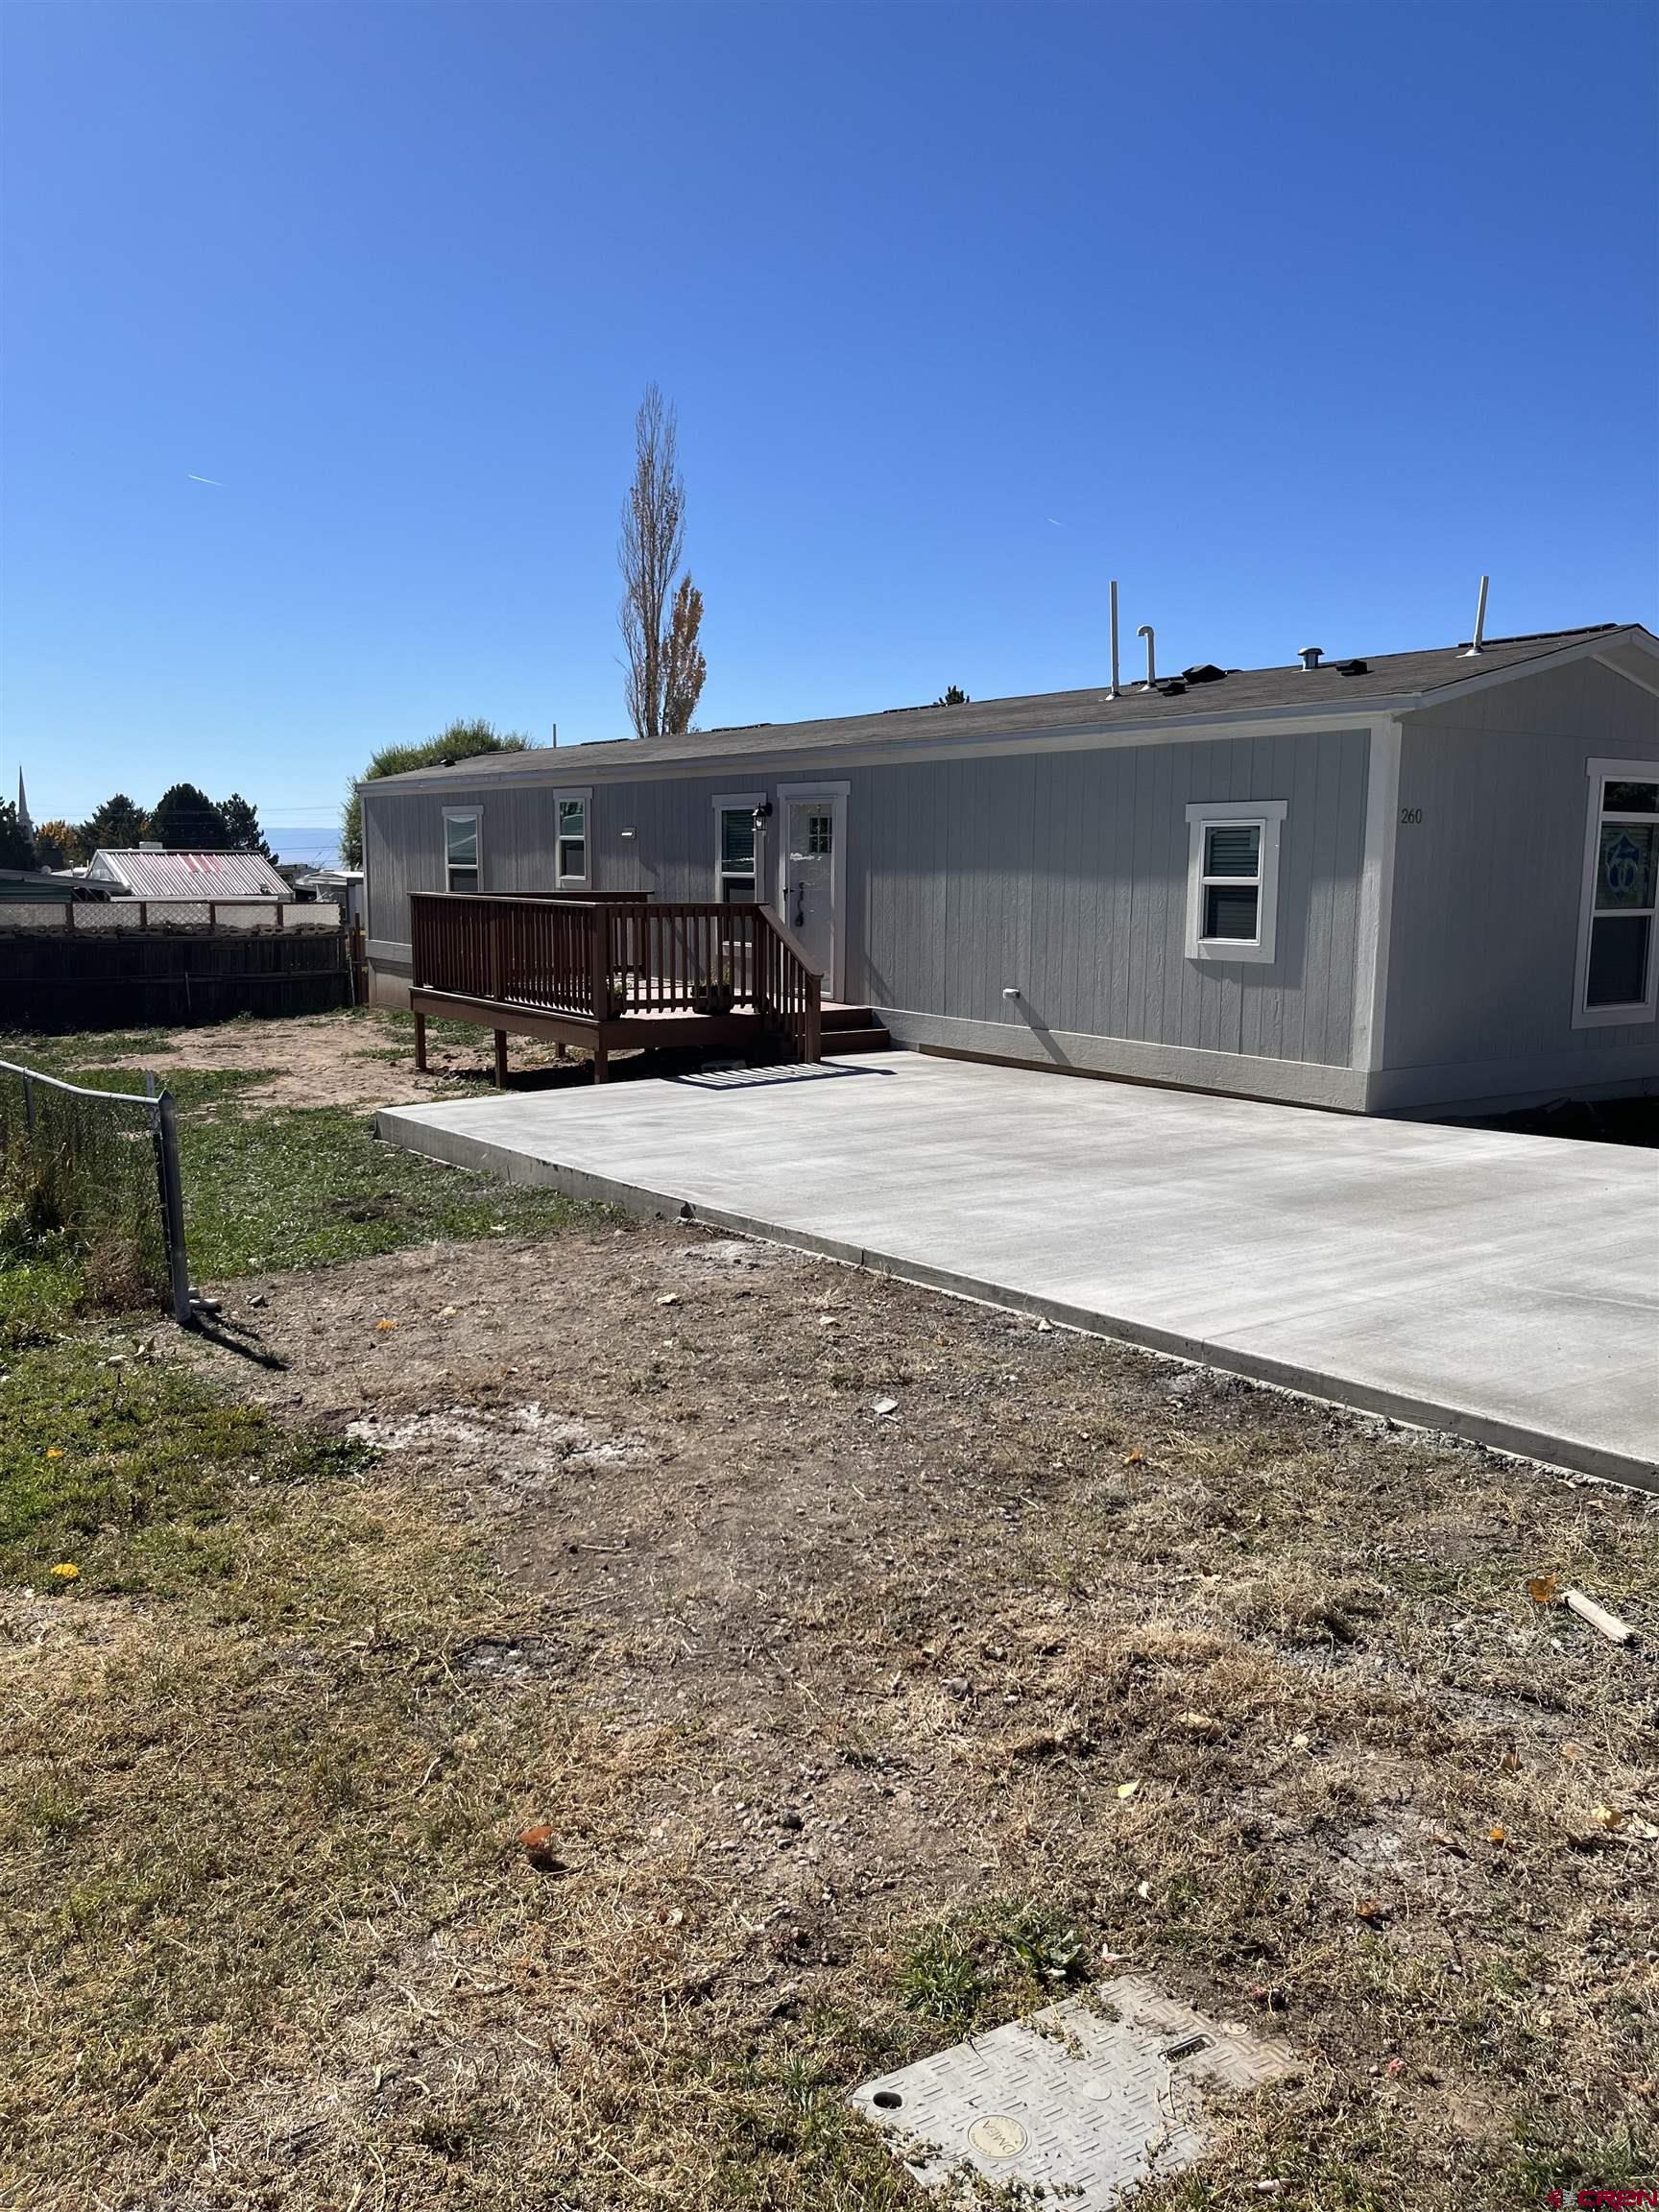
[{"left": 0, "top": 1060, "right": 190, "bottom": 1327}]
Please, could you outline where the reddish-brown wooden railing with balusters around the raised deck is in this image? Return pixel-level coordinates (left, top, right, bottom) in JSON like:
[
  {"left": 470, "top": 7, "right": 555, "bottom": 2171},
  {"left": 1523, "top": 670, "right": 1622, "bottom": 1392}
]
[{"left": 409, "top": 892, "right": 823, "bottom": 1060}]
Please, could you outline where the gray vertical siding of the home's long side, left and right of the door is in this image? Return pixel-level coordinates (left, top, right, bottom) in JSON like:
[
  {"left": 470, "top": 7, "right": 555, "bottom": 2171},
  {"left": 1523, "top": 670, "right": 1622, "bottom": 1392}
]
[{"left": 363, "top": 730, "right": 1369, "bottom": 1067}]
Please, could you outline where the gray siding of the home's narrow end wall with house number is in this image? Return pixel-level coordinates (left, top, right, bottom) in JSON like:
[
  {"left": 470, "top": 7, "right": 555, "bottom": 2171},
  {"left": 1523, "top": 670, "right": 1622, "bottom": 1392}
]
[{"left": 1376, "top": 660, "right": 1659, "bottom": 1106}]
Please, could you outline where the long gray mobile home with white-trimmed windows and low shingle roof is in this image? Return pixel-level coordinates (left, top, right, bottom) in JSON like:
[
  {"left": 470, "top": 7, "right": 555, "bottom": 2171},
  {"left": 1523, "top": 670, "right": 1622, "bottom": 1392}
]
[{"left": 358, "top": 624, "right": 1659, "bottom": 1113}]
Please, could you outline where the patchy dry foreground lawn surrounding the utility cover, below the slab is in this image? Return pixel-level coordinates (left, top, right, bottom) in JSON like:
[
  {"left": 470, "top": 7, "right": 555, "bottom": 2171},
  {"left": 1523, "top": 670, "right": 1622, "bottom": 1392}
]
[{"left": 0, "top": 1216, "right": 1659, "bottom": 2212}]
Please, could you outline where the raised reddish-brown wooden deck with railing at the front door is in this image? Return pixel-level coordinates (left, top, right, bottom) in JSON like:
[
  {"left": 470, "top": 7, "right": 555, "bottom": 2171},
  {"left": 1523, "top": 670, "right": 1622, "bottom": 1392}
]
[{"left": 409, "top": 892, "right": 823, "bottom": 1084}]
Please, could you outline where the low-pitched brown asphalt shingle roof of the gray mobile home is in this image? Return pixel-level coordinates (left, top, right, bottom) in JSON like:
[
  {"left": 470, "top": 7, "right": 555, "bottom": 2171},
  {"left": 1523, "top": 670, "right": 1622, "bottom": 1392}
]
[{"left": 369, "top": 621, "right": 1625, "bottom": 785}]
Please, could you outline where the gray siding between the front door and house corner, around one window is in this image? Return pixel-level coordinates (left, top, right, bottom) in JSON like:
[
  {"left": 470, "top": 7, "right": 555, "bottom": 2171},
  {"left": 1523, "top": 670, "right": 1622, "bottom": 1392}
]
[{"left": 862, "top": 730, "right": 1369, "bottom": 1067}]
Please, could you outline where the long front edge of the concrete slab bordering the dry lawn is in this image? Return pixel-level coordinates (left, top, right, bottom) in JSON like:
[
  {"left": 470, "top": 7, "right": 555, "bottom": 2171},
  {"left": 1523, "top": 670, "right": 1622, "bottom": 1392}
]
[{"left": 373, "top": 1106, "right": 1659, "bottom": 1496}]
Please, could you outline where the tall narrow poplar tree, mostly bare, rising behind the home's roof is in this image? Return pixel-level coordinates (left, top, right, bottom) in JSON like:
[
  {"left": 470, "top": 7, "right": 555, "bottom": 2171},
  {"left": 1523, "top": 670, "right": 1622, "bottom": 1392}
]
[{"left": 617, "top": 385, "right": 708, "bottom": 736}]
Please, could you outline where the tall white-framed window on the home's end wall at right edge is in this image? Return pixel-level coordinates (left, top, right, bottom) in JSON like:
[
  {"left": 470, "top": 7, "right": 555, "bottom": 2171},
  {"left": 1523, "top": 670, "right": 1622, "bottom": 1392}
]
[{"left": 1573, "top": 761, "right": 1659, "bottom": 1028}]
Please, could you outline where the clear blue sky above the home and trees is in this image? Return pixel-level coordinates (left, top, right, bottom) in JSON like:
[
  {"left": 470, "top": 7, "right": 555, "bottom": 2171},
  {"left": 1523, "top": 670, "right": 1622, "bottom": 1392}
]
[{"left": 0, "top": 0, "right": 1659, "bottom": 849}]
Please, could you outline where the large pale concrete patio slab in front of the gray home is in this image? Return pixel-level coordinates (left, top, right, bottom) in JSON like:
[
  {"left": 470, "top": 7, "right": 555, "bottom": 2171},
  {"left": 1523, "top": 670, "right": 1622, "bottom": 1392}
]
[{"left": 378, "top": 1053, "right": 1659, "bottom": 1489}]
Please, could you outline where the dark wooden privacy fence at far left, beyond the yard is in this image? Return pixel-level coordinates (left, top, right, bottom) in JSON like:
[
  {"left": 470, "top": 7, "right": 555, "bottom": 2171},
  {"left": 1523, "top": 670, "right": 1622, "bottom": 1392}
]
[{"left": 0, "top": 918, "right": 351, "bottom": 1031}]
